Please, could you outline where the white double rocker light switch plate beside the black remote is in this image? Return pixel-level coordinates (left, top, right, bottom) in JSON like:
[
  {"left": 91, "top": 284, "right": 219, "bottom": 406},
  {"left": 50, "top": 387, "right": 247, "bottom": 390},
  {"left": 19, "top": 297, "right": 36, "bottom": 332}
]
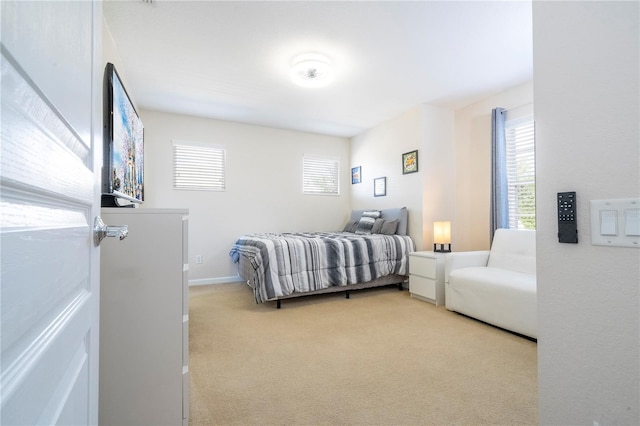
[{"left": 590, "top": 198, "right": 640, "bottom": 248}]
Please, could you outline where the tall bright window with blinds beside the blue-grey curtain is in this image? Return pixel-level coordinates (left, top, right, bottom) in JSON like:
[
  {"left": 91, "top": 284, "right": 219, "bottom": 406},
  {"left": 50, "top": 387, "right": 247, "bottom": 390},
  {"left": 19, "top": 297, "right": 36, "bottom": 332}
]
[{"left": 505, "top": 118, "right": 536, "bottom": 229}]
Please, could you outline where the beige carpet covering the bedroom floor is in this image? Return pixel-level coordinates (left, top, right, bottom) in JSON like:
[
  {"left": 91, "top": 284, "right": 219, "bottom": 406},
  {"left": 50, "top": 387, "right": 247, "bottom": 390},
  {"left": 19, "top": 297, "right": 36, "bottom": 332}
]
[{"left": 189, "top": 283, "right": 538, "bottom": 426}]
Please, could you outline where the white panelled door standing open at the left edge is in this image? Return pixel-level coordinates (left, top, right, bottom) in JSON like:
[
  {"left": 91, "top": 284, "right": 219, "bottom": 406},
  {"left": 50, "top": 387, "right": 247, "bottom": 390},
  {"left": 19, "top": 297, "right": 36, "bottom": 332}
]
[{"left": 0, "top": 0, "right": 102, "bottom": 425}]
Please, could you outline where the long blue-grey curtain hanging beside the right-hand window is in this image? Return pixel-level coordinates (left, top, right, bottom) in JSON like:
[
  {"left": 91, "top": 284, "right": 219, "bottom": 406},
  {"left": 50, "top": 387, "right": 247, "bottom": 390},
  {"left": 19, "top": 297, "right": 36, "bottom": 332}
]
[{"left": 489, "top": 108, "right": 509, "bottom": 242}]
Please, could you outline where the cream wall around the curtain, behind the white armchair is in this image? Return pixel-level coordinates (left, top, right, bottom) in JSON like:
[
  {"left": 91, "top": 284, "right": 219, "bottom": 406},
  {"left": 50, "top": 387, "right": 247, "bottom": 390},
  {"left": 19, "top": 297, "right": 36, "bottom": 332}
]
[{"left": 451, "top": 82, "right": 533, "bottom": 251}]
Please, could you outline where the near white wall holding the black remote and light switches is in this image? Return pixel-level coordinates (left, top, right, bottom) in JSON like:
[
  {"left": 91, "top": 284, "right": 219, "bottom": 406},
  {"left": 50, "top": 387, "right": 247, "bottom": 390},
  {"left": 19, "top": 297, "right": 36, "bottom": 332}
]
[{"left": 533, "top": 1, "right": 640, "bottom": 425}]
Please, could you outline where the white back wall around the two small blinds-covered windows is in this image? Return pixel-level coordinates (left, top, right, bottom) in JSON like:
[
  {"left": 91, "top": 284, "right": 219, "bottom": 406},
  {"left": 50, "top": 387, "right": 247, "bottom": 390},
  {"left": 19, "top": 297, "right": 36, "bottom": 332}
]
[{"left": 140, "top": 110, "right": 351, "bottom": 282}]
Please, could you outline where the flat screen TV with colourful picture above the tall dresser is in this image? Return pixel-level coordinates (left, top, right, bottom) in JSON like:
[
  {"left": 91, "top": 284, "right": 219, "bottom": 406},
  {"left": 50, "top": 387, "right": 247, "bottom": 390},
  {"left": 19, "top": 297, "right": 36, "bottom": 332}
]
[{"left": 102, "top": 63, "right": 144, "bottom": 207}]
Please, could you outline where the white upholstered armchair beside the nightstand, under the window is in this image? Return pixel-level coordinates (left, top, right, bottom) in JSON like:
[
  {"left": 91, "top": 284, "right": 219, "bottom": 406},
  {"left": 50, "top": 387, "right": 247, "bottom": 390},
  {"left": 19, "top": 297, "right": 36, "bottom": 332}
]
[{"left": 445, "top": 229, "right": 538, "bottom": 338}]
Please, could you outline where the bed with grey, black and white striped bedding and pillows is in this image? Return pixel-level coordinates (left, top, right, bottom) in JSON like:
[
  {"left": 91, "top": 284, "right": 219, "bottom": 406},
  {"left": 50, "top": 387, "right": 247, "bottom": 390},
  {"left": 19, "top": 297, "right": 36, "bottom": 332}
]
[{"left": 229, "top": 207, "right": 415, "bottom": 309}]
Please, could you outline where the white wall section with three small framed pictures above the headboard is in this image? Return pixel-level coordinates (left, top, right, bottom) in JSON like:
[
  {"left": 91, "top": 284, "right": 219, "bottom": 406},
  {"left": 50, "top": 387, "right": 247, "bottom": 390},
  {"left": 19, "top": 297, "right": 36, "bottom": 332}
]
[{"left": 351, "top": 105, "right": 455, "bottom": 250}]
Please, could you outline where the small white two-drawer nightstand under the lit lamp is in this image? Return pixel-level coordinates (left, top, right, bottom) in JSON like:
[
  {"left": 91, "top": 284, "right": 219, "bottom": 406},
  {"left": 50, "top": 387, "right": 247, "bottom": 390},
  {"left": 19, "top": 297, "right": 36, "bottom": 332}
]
[{"left": 409, "top": 251, "right": 445, "bottom": 305}]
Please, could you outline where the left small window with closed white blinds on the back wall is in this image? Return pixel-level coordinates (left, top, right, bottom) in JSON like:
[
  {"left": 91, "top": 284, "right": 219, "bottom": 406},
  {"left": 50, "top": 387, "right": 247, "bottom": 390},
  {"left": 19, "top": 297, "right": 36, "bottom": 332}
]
[{"left": 173, "top": 141, "right": 226, "bottom": 191}]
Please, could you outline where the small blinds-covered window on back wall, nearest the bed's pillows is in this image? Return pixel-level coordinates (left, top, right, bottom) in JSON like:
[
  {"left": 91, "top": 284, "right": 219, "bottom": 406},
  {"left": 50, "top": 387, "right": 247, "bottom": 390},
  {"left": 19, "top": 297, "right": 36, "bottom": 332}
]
[{"left": 302, "top": 156, "right": 340, "bottom": 195}]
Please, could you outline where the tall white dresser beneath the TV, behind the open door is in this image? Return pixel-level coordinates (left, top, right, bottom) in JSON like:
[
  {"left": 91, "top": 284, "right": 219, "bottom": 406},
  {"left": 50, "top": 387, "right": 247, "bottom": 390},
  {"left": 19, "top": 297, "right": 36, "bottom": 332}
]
[{"left": 99, "top": 207, "right": 189, "bottom": 425}]
